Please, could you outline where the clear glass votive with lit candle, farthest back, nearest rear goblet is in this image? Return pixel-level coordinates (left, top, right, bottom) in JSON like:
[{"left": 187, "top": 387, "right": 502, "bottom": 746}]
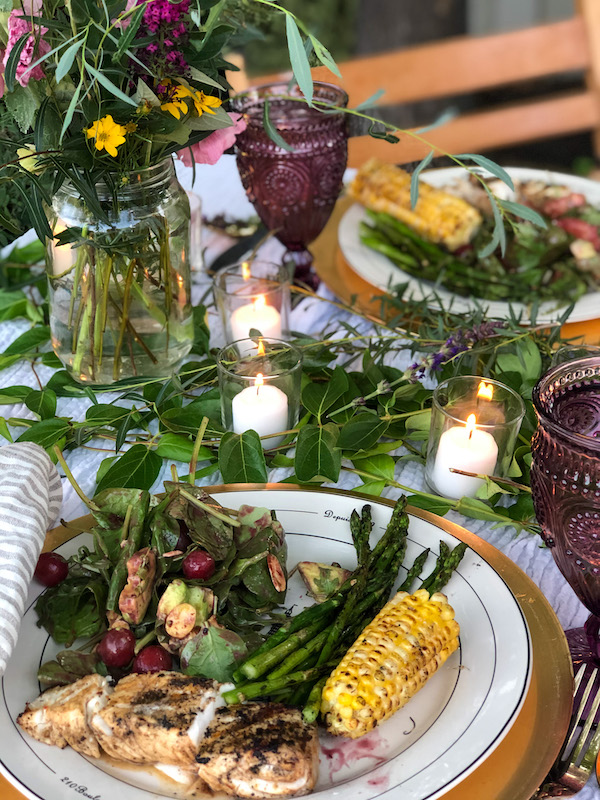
[{"left": 213, "top": 259, "right": 293, "bottom": 344}]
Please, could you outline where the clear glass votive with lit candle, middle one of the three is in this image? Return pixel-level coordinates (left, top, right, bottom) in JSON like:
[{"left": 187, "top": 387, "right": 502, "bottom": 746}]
[{"left": 217, "top": 336, "right": 302, "bottom": 450}]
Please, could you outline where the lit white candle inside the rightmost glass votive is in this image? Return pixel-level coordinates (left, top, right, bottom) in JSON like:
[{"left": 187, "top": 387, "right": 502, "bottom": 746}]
[{"left": 431, "top": 414, "right": 498, "bottom": 499}]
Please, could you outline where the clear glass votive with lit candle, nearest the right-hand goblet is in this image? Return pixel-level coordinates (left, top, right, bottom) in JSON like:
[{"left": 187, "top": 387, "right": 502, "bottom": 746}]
[{"left": 425, "top": 375, "right": 525, "bottom": 500}]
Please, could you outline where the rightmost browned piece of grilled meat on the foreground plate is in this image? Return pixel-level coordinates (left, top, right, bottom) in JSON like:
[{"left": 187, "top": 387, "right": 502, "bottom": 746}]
[{"left": 196, "top": 703, "right": 319, "bottom": 798}]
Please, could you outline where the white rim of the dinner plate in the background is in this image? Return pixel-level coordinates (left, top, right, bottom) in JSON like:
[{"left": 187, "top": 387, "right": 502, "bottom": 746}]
[{"left": 338, "top": 167, "right": 600, "bottom": 324}]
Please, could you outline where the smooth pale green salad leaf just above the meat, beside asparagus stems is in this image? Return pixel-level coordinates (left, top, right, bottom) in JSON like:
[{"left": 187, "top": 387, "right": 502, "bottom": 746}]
[{"left": 181, "top": 622, "right": 247, "bottom": 682}]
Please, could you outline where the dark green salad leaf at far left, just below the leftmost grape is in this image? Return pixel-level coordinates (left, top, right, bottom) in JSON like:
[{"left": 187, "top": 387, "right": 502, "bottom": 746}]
[{"left": 35, "top": 577, "right": 107, "bottom": 647}]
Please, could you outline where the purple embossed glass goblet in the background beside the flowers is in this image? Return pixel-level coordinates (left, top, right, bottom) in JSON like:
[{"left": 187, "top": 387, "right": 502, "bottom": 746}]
[{"left": 233, "top": 82, "right": 348, "bottom": 288}]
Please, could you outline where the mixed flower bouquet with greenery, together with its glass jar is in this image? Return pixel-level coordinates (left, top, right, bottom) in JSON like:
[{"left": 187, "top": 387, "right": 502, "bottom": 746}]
[{"left": 0, "top": 0, "right": 335, "bottom": 383}]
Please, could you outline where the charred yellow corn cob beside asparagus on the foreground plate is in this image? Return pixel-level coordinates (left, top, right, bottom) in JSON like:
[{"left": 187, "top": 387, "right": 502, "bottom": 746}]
[{"left": 321, "top": 589, "right": 460, "bottom": 739}]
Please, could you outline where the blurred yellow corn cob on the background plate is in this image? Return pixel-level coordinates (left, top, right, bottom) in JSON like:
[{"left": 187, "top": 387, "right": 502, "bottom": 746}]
[{"left": 348, "top": 158, "right": 481, "bottom": 250}]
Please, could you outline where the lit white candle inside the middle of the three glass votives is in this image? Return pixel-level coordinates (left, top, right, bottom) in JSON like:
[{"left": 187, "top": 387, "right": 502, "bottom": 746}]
[{"left": 231, "top": 373, "right": 288, "bottom": 450}]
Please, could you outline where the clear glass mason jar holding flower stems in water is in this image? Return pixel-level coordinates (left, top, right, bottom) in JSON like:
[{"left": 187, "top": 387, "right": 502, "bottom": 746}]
[{"left": 46, "top": 159, "right": 193, "bottom": 383}]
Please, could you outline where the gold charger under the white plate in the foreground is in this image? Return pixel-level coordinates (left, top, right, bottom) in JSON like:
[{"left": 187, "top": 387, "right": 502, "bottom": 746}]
[{"left": 0, "top": 484, "right": 573, "bottom": 800}]
